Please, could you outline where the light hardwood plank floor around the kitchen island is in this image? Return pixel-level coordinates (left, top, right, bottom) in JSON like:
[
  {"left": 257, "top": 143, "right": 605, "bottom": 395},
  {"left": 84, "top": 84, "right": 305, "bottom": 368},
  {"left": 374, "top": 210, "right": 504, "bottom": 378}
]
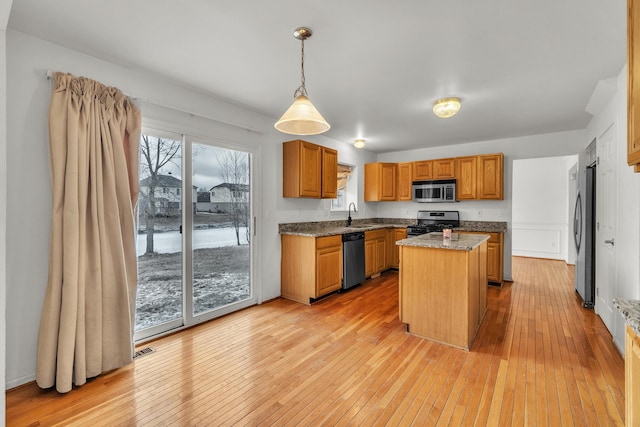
[{"left": 7, "top": 258, "right": 624, "bottom": 426}]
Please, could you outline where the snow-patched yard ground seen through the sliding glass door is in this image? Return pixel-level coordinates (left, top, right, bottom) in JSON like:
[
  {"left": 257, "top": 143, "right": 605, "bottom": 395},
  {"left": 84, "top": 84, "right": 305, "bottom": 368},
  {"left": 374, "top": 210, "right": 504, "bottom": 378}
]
[{"left": 136, "top": 213, "right": 251, "bottom": 330}]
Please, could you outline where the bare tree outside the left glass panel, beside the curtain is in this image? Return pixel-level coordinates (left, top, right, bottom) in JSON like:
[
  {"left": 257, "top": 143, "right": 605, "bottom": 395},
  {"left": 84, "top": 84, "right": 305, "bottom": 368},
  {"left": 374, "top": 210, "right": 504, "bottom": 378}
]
[{"left": 140, "top": 135, "right": 180, "bottom": 254}]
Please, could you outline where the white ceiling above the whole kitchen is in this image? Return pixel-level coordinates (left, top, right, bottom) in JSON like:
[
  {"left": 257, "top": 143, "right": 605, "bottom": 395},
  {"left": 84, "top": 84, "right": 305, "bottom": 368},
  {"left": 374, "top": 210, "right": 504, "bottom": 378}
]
[{"left": 8, "top": 0, "right": 626, "bottom": 152}]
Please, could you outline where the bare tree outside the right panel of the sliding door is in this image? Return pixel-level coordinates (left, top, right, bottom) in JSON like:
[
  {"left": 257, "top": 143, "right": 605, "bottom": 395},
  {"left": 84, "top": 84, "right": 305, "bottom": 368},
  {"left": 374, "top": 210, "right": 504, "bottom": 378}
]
[{"left": 217, "top": 150, "right": 246, "bottom": 245}]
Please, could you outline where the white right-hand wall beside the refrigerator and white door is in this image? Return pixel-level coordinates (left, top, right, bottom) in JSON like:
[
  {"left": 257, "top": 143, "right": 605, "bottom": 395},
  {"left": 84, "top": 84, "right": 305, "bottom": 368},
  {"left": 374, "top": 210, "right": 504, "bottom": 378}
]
[{"left": 581, "top": 67, "right": 640, "bottom": 354}]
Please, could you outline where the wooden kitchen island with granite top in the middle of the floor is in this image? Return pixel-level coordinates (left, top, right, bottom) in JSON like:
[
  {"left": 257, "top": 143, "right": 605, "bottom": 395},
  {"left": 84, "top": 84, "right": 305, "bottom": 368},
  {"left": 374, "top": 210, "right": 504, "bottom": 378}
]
[{"left": 396, "top": 233, "right": 489, "bottom": 350}]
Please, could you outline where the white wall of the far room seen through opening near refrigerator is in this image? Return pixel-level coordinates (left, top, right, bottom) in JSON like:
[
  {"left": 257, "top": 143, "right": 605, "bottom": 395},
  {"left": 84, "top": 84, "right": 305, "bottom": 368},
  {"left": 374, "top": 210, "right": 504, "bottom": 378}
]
[{"left": 511, "top": 155, "right": 578, "bottom": 261}]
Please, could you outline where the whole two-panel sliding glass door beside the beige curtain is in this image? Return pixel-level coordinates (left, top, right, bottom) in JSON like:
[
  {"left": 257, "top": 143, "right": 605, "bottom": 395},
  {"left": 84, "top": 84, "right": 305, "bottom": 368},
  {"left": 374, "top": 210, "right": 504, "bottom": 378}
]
[{"left": 135, "top": 130, "right": 255, "bottom": 340}]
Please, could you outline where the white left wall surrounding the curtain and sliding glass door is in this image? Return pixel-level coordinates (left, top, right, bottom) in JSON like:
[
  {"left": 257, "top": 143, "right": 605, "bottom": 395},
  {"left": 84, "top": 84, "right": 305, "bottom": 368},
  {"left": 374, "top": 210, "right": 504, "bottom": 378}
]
[{"left": 0, "top": 30, "right": 375, "bottom": 392}]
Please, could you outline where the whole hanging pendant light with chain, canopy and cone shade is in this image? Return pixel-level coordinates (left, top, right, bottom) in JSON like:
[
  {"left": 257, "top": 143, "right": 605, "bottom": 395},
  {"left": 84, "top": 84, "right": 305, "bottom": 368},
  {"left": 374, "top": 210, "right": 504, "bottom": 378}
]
[{"left": 274, "top": 27, "right": 331, "bottom": 135}]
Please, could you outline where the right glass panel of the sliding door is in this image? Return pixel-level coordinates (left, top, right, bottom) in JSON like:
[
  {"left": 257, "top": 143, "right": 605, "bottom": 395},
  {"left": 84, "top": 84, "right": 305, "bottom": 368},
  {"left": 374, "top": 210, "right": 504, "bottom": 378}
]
[{"left": 192, "top": 143, "right": 251, "bottom": 316}]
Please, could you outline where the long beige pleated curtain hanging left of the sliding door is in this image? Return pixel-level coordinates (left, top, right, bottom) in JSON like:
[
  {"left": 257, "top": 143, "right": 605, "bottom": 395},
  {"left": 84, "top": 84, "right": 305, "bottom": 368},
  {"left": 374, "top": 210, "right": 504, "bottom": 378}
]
[{"left": 36, "top": 73, "right": 141, "bottom": 393}]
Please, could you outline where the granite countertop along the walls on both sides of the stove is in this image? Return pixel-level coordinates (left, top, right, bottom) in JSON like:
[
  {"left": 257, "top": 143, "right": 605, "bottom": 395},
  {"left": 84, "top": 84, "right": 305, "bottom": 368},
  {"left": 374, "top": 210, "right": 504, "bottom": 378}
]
[{"left": 278, "top": 218, "right": 507, "bottom": 237}]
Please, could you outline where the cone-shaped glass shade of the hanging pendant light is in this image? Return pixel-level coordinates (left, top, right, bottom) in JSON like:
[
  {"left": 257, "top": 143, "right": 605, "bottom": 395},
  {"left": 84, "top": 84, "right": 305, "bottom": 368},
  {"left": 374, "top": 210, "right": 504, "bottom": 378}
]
[{"left": 274, "top": 95, "right": 331, "bottom": 135}]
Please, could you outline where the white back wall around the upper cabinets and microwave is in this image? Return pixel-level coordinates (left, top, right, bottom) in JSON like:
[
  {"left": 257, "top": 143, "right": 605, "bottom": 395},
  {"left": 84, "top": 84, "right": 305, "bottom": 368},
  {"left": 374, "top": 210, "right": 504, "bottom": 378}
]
[{"left": 378, "top": 132, "right": 588, "bottom": 280}]
